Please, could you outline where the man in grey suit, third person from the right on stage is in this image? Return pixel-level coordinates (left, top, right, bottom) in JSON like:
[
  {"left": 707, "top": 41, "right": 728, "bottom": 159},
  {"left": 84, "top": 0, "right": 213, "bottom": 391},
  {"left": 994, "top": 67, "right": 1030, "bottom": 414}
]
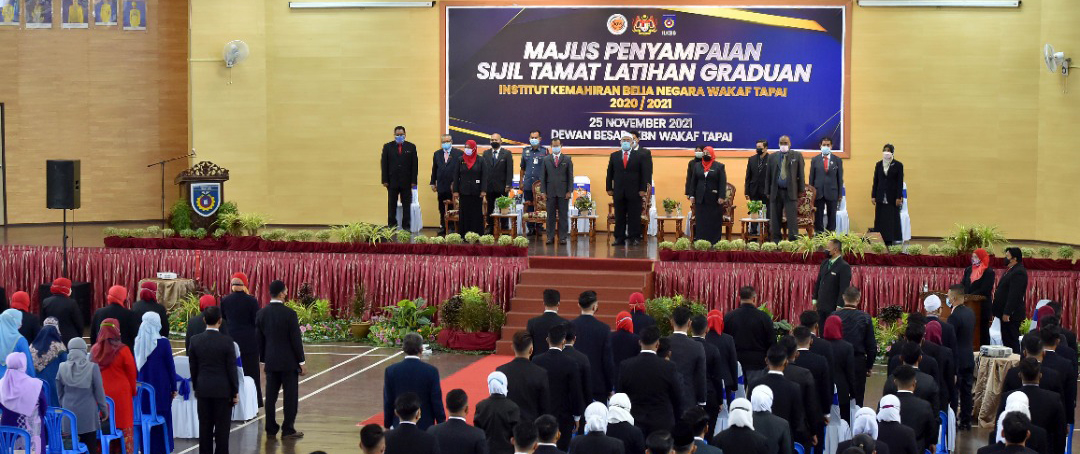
[{"left": 766, "top": 135, "right": 806, "bottom": 242}]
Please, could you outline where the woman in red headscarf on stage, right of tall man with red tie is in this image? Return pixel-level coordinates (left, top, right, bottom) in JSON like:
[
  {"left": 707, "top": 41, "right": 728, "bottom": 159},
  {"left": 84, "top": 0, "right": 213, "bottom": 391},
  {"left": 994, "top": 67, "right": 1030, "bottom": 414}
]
[{"left": 687, "top": 147, "right": 728, "bottom": 243}]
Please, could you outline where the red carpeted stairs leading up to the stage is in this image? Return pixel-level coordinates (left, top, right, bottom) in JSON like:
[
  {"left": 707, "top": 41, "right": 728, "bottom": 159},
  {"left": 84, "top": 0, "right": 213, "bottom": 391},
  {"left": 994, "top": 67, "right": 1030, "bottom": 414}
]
[{"left": 496, "top": 257, "right": 653, "bottom": 355}]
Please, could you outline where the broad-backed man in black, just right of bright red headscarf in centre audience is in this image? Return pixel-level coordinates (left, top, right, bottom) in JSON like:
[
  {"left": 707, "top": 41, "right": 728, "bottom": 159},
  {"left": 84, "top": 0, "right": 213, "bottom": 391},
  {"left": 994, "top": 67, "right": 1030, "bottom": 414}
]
[{"left": 724, "top": 285, "right": 777, "bottom": 383}]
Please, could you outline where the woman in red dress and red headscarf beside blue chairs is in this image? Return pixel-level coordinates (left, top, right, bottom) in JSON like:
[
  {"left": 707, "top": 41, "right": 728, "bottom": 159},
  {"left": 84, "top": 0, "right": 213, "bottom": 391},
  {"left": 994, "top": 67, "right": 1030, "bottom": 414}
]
[{"left": 90, "top": 319, "right": 138, "bottom": 453}]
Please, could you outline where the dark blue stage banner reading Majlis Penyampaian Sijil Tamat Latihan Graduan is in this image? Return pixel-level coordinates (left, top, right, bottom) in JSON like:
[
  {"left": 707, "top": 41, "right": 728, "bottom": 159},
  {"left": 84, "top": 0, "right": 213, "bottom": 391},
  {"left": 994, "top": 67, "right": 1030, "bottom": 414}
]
[{"left": 446, "top": 5, "right": 846, "bottom": 152}]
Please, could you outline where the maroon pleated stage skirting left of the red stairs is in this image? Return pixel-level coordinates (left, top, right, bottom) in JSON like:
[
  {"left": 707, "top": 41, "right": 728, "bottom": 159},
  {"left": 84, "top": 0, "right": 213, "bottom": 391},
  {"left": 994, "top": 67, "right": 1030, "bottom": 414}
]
[{"left": 0, "top": 245, "right": 528, "bottom": 313}]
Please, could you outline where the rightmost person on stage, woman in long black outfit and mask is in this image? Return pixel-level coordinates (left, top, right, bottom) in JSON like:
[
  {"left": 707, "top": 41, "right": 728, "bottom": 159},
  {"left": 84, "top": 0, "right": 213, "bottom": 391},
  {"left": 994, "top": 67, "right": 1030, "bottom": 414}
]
[{"left": 870, "top": 144, "right": 904, "bottom": 244}]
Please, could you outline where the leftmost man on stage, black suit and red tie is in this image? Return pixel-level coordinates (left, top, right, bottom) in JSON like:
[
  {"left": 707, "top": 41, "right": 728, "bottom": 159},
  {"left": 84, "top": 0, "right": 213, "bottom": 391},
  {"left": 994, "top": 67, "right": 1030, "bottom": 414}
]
[{"left": 380, "top": 126, "right": 419, "bottom": 230}]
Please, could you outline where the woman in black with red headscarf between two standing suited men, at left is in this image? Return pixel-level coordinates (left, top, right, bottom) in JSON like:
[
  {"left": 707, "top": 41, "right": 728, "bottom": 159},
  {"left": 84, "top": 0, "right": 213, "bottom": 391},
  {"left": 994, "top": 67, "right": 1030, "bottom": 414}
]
[{"left": 219, "top": 273, "right": 262, "bottom": 406}]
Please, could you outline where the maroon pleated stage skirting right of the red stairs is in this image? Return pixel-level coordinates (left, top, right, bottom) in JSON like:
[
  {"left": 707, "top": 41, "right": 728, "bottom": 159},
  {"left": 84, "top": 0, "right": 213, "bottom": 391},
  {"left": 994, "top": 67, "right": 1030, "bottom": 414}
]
[{"left": 654, "top": 259, "right": 1080, "bottom": 326}]
